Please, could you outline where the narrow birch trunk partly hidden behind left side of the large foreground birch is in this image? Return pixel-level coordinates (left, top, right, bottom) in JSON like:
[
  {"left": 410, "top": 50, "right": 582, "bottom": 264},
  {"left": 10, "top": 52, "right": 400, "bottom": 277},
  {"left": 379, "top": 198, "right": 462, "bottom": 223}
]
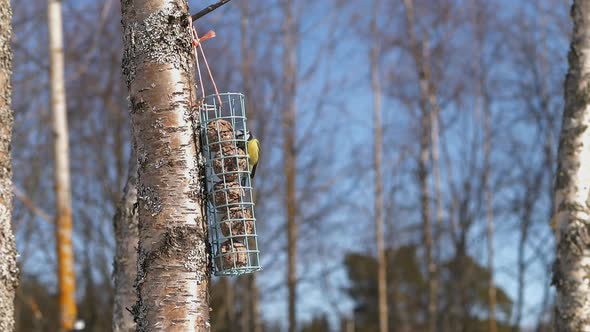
[{"left": 113, "top": 147, "right": 139, "bottom": 332}]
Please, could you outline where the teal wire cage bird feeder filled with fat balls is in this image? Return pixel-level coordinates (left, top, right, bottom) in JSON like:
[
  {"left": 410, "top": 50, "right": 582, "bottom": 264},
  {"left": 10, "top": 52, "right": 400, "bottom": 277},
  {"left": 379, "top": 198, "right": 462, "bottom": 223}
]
[{"left": 200, "top": 93, "right": 262, "bottom": 276}]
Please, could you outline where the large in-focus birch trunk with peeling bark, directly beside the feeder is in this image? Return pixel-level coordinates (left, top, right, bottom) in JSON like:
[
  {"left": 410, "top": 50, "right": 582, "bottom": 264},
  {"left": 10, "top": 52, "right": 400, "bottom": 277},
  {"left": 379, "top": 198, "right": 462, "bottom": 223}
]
[{"left": 121, "top": 0, "right": 210, "bottom": 331}]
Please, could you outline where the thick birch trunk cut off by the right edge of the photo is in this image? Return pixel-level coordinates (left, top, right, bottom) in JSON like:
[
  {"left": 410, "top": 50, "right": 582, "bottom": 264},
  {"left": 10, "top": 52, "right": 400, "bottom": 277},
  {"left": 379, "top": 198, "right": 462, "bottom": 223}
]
[{"left": 553, "top": 0, "right": 590, "bottom": 332}]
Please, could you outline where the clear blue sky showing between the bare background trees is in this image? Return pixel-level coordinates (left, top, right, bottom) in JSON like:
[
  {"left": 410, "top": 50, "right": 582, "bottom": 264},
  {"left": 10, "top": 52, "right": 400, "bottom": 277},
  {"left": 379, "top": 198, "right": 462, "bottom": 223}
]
[{"left": 8, "top": 0, "right": 567, "bottom": 324}]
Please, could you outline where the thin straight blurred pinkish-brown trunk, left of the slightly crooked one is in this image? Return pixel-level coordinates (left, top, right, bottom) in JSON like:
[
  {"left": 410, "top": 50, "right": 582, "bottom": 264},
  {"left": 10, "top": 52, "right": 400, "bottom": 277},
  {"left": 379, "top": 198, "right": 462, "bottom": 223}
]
[{"left": 369, "top": 0, "right": 389, "bottom": 332}]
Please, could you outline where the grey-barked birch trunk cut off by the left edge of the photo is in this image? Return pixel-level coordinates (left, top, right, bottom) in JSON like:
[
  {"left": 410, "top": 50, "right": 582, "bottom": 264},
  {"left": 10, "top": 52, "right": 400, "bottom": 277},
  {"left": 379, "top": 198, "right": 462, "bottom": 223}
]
[{"left": 0, "top": 0, "right": 18, "bottom": 332}]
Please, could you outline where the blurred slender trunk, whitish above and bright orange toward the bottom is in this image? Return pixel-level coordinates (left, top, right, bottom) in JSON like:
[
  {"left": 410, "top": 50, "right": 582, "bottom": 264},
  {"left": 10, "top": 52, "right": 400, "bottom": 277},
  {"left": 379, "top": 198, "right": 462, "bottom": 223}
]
[{"left": 47, "top": 0, "right": 77, "bottom": 331}]
